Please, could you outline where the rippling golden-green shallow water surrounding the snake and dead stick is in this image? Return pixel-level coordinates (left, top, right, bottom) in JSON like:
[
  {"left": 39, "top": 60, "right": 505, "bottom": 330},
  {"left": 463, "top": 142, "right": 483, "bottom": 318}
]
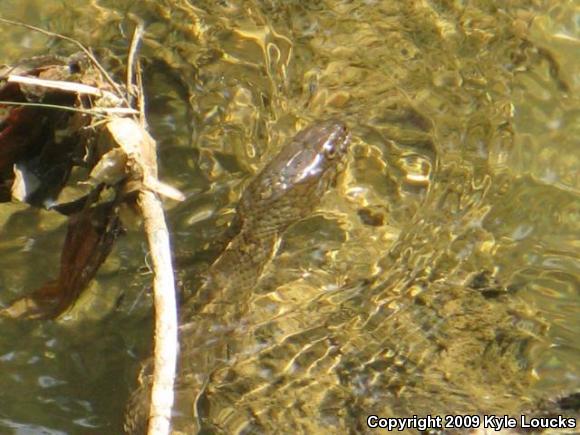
[{"left": 0, "top": 0, "right": 580, "bottom": 434}]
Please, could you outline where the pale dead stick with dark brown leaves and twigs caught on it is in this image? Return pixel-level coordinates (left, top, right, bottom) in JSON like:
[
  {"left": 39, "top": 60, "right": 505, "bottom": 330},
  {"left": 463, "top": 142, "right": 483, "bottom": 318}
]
[{"left": 0, "top": 19, "right": 184, "bottom": 434}]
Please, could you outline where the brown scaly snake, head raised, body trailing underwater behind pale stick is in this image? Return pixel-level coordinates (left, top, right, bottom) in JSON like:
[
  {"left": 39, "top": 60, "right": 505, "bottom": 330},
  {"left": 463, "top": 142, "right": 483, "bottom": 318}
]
[{"left": 125, "top": 119, "right": 351, "bottom": 433}]
